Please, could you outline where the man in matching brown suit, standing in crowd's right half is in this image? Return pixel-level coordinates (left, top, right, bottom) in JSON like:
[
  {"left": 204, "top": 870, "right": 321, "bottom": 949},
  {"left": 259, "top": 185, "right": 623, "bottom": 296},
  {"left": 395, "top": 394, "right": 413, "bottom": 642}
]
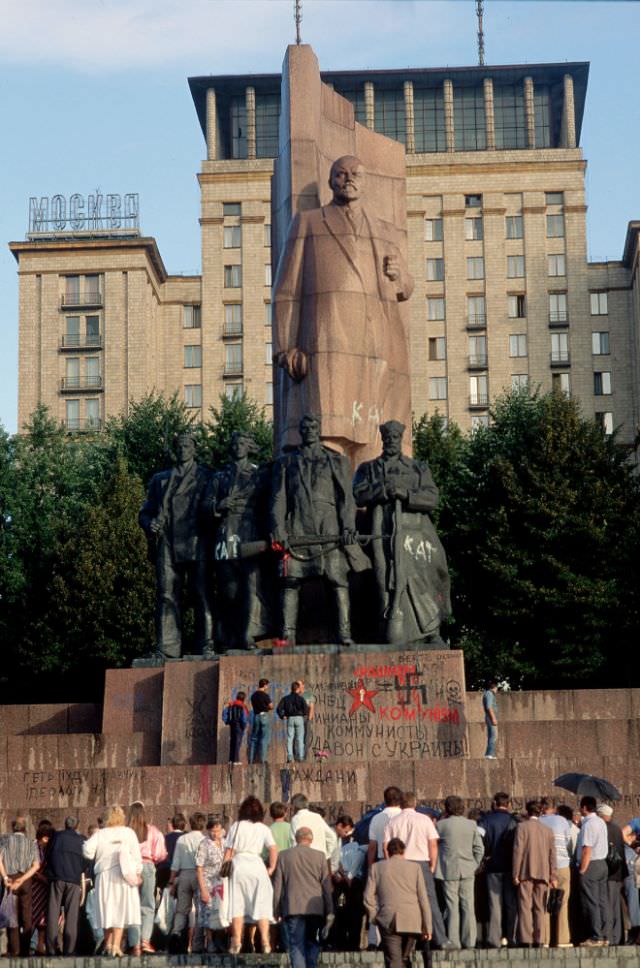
[{"left": 513, "top": 800, "right": 558, "bottom": 948}]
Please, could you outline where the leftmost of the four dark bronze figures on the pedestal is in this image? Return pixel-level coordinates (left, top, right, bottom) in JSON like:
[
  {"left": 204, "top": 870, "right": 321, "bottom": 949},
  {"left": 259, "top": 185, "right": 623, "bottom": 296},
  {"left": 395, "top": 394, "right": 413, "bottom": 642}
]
[{"left": 138, "top": 434, "right": 213, "bottom": 659}]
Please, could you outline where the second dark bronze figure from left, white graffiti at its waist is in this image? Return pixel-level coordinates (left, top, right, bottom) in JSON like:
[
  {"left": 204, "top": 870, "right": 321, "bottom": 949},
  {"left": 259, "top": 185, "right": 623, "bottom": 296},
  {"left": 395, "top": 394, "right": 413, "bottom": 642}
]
[{"left": 207, "top": 431, "right": 270, "bottom": 651}]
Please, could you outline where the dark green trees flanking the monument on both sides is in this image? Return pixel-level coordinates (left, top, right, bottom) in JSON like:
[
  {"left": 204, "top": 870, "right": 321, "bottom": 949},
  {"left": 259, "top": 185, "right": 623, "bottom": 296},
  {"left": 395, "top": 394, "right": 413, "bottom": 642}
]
[{"left": 0, "top": 392, "right": 640, "bottom": 702}]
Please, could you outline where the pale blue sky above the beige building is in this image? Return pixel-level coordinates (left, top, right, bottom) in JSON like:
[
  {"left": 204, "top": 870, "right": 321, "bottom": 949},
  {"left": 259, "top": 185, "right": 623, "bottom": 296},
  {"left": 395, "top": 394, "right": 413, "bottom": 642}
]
[{"left": 0, "top": 0, "right": 640, "bottom": 432}]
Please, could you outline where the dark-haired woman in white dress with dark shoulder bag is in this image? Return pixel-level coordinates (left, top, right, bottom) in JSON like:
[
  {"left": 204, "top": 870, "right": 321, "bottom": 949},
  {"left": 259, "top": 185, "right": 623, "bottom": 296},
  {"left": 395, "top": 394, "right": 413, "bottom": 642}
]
[{"left": 224, "top": 797, "right": 278, "bottom": 954}]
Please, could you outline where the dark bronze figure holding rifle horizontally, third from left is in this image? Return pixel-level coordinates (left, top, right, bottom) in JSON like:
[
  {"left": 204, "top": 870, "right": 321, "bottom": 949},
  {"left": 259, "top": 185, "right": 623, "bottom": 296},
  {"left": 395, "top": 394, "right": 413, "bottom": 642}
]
[{"left": 270, "top": 414, "right": 369, "bottom": 645}]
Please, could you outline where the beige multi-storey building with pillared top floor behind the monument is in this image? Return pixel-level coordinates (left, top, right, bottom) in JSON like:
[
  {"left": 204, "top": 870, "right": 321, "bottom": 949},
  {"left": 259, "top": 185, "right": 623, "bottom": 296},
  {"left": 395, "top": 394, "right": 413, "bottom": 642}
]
[{"left": 11, "top": 56, "right": 640, "bottom": 439}]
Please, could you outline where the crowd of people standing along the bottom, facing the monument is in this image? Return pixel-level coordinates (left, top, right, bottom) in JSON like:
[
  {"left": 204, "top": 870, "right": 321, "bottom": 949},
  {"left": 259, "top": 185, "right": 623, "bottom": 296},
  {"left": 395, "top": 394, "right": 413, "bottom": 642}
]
[{"left": 0, "top": 786, "right": 640, "bottom": 968}]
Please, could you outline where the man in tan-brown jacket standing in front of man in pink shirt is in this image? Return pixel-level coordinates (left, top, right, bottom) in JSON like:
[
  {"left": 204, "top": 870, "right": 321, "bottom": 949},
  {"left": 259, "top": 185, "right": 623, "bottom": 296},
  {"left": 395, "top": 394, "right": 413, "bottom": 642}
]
[{"left": 364, "top": 837, "right": 431, "bottom": 968}]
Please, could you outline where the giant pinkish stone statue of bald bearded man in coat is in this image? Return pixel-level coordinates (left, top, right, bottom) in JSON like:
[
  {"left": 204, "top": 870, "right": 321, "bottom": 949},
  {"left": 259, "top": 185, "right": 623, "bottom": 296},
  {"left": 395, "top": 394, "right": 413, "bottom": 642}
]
[{"left": 273, "top": 156, "right": 413, "bottom": 466}]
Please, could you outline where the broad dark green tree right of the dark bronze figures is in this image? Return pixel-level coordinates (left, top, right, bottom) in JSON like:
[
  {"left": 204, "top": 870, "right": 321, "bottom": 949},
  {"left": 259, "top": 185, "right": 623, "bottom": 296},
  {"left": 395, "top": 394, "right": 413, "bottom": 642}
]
[{"left": 441, "top": 392, "right": 640, "bottom": 686}]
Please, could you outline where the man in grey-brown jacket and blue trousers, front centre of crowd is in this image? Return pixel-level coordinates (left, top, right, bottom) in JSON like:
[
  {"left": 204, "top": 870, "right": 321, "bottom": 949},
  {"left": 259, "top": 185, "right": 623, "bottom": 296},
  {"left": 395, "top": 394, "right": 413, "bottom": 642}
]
[{"left": 273, "top": 827, "right": 334, "bottom": 968}]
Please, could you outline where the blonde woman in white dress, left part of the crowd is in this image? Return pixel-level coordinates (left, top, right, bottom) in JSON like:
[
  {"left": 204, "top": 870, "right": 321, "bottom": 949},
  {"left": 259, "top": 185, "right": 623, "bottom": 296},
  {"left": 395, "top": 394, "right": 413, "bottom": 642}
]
[{"left": 83, "top": 807, "right": 142, "bottom": 958}]
